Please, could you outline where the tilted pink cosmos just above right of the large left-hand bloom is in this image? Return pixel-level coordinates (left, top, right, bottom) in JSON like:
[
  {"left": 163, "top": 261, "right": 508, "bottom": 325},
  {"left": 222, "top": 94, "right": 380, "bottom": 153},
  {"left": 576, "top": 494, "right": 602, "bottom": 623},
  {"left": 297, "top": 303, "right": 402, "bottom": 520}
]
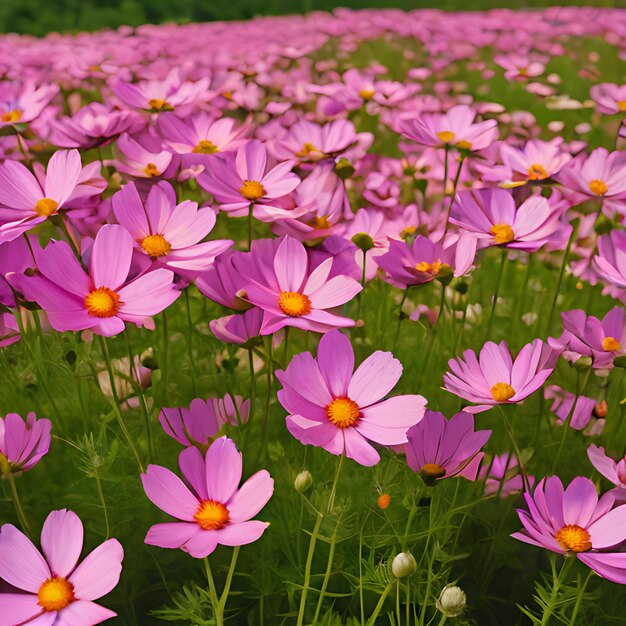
[{"left": 112, "top": 181, "right": 233, "bottom": 273}]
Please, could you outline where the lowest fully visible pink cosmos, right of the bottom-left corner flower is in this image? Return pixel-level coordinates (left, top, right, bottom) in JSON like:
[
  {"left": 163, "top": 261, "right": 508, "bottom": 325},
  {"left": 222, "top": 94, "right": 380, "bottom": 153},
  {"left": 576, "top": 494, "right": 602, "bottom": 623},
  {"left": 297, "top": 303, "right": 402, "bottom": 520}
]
[{"left": 141, "top": 437, "right": 274, "bottom": 558}]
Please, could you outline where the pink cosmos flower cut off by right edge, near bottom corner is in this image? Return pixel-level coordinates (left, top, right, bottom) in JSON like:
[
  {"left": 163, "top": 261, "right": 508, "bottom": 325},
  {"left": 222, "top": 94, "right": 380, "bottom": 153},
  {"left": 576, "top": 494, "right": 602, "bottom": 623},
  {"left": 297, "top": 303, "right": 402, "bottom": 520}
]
[{"left": 511, "top": 476, "right": 626, "bottom": 584}]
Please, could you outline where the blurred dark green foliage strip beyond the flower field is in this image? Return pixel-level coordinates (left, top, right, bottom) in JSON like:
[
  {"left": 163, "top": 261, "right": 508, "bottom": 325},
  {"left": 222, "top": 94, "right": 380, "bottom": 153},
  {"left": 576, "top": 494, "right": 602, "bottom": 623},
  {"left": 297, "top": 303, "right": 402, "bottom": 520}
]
[{"left": 0, "top": 0, "right": 626, "bottom": 35}]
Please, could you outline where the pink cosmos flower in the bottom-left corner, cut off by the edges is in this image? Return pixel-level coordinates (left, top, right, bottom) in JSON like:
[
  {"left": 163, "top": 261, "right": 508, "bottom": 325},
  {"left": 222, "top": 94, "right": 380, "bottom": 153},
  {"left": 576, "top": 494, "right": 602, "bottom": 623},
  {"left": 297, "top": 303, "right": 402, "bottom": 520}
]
[{"left": 0, "top": 509, "right": 124, "bottom": 626}]
